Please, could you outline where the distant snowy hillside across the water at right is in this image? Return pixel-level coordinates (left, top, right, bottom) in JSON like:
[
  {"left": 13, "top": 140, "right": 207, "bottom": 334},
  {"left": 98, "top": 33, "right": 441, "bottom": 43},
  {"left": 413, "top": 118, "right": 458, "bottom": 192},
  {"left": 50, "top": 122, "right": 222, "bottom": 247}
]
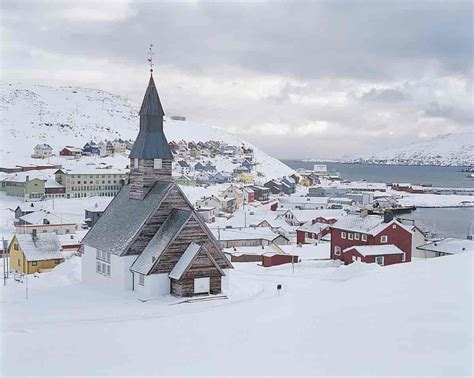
[{"left": 351, "top": 133, "right": 474, "bottom": 166}]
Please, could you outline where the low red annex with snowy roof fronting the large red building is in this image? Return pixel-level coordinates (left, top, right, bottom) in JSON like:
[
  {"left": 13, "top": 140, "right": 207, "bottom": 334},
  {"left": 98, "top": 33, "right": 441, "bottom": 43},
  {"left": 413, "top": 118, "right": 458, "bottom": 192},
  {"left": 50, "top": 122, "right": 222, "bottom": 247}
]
[{"left": 342, "top": 244, "right": 406, "bottom": 266}]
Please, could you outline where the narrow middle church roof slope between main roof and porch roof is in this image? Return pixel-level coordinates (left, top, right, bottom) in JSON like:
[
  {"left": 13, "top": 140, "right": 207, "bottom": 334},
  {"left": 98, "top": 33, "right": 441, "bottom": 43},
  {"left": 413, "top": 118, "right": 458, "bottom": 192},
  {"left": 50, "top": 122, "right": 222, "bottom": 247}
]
[{"left": 130, "top": 209, "right": 192, "bottom": 274}]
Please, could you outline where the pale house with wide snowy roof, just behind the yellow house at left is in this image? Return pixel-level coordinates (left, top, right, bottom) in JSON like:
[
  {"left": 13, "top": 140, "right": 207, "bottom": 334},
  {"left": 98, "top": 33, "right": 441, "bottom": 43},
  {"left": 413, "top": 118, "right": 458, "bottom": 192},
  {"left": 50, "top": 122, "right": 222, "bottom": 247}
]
[{"left": 15, "top": 209, "right": 77, "bottom": 235}]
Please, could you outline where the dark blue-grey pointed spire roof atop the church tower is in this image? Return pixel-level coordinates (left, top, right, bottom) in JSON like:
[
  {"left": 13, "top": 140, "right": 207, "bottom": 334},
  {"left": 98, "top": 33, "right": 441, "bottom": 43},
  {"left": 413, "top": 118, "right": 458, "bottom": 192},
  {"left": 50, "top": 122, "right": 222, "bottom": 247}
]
[{"left": 130, "top": 76, "right": 173, "bottom": 160}]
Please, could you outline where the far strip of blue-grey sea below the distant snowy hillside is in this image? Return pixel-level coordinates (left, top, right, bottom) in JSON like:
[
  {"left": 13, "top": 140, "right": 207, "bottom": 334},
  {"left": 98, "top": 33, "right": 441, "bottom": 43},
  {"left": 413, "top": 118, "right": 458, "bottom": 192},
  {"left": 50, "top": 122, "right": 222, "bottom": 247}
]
[{"left": 282, "top": 160, "right": 474, "bottom": 188}]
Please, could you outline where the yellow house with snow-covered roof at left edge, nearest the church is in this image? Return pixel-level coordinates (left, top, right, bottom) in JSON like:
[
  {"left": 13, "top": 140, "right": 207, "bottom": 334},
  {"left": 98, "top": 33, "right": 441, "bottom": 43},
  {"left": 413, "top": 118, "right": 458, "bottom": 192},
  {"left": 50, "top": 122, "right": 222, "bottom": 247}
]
[{"left": 8, "top": 233, "right": 64, "bottom": 274}]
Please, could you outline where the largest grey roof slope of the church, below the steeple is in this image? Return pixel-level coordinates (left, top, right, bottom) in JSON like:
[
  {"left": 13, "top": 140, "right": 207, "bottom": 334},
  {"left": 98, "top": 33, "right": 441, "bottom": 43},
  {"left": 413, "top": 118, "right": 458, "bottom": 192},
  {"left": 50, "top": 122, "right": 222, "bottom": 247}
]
[{"left": 82, "top": 181, "right": 174, "bottom": 255}]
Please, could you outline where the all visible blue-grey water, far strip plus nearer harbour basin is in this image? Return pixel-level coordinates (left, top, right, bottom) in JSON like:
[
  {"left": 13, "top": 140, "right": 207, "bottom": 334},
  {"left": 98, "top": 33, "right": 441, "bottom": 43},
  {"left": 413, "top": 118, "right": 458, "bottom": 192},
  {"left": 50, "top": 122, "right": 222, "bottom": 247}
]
[{"left": 282, "top": 160, "right": 474, "bottom": 239}]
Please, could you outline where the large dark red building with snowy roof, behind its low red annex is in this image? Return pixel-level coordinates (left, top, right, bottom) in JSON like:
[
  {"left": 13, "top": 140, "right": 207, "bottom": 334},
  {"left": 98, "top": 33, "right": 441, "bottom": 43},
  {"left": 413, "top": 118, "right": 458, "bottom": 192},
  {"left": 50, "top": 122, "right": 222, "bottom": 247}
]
[{"left": 331, "top": 213, "right": 412, "bottom": 262}]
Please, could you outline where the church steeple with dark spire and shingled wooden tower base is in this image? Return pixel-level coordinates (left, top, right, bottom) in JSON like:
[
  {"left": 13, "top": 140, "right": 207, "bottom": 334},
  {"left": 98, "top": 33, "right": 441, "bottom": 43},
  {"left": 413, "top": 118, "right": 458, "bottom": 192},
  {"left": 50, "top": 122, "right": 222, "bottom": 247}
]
[{"left": 130, "top": 62, "right": 173, "bottom": 200}]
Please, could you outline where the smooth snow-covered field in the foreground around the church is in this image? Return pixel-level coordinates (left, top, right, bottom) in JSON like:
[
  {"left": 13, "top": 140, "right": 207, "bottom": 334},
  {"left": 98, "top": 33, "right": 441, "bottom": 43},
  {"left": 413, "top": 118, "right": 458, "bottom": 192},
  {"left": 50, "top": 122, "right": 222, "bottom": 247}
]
[{"left": 0, "top": 254, "right": 474, "bottom": 376}]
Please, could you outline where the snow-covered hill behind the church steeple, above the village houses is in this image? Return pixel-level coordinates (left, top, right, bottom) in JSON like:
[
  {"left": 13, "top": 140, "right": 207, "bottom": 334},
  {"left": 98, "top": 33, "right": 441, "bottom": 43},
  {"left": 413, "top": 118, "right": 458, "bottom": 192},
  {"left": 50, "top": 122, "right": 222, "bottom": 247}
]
[{"left": 0, "top": 82, "right": 293, "bottom": 178}]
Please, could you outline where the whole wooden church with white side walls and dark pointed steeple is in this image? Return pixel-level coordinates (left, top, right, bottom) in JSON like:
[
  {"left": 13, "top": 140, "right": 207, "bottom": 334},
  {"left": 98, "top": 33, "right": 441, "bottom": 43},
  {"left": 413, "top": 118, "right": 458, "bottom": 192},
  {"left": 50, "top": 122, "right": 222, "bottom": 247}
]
[{"left": 81, "top": 73, "right": 232, "bottom": 299}]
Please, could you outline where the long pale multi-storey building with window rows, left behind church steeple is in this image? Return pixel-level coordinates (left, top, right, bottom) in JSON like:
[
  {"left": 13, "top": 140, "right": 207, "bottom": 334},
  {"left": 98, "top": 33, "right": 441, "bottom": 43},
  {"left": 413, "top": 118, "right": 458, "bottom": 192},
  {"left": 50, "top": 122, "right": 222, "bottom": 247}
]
[{"left": 55, "top": 168, "right": 128, "bottom": 198}]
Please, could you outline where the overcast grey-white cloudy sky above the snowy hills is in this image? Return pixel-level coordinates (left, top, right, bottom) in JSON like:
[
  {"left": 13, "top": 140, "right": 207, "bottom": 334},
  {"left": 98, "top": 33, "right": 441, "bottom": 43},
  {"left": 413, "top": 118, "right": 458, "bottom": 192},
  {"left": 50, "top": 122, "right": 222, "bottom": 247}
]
[{"left": 1, "top": 0, "right": 474, "bottom": 158}]
